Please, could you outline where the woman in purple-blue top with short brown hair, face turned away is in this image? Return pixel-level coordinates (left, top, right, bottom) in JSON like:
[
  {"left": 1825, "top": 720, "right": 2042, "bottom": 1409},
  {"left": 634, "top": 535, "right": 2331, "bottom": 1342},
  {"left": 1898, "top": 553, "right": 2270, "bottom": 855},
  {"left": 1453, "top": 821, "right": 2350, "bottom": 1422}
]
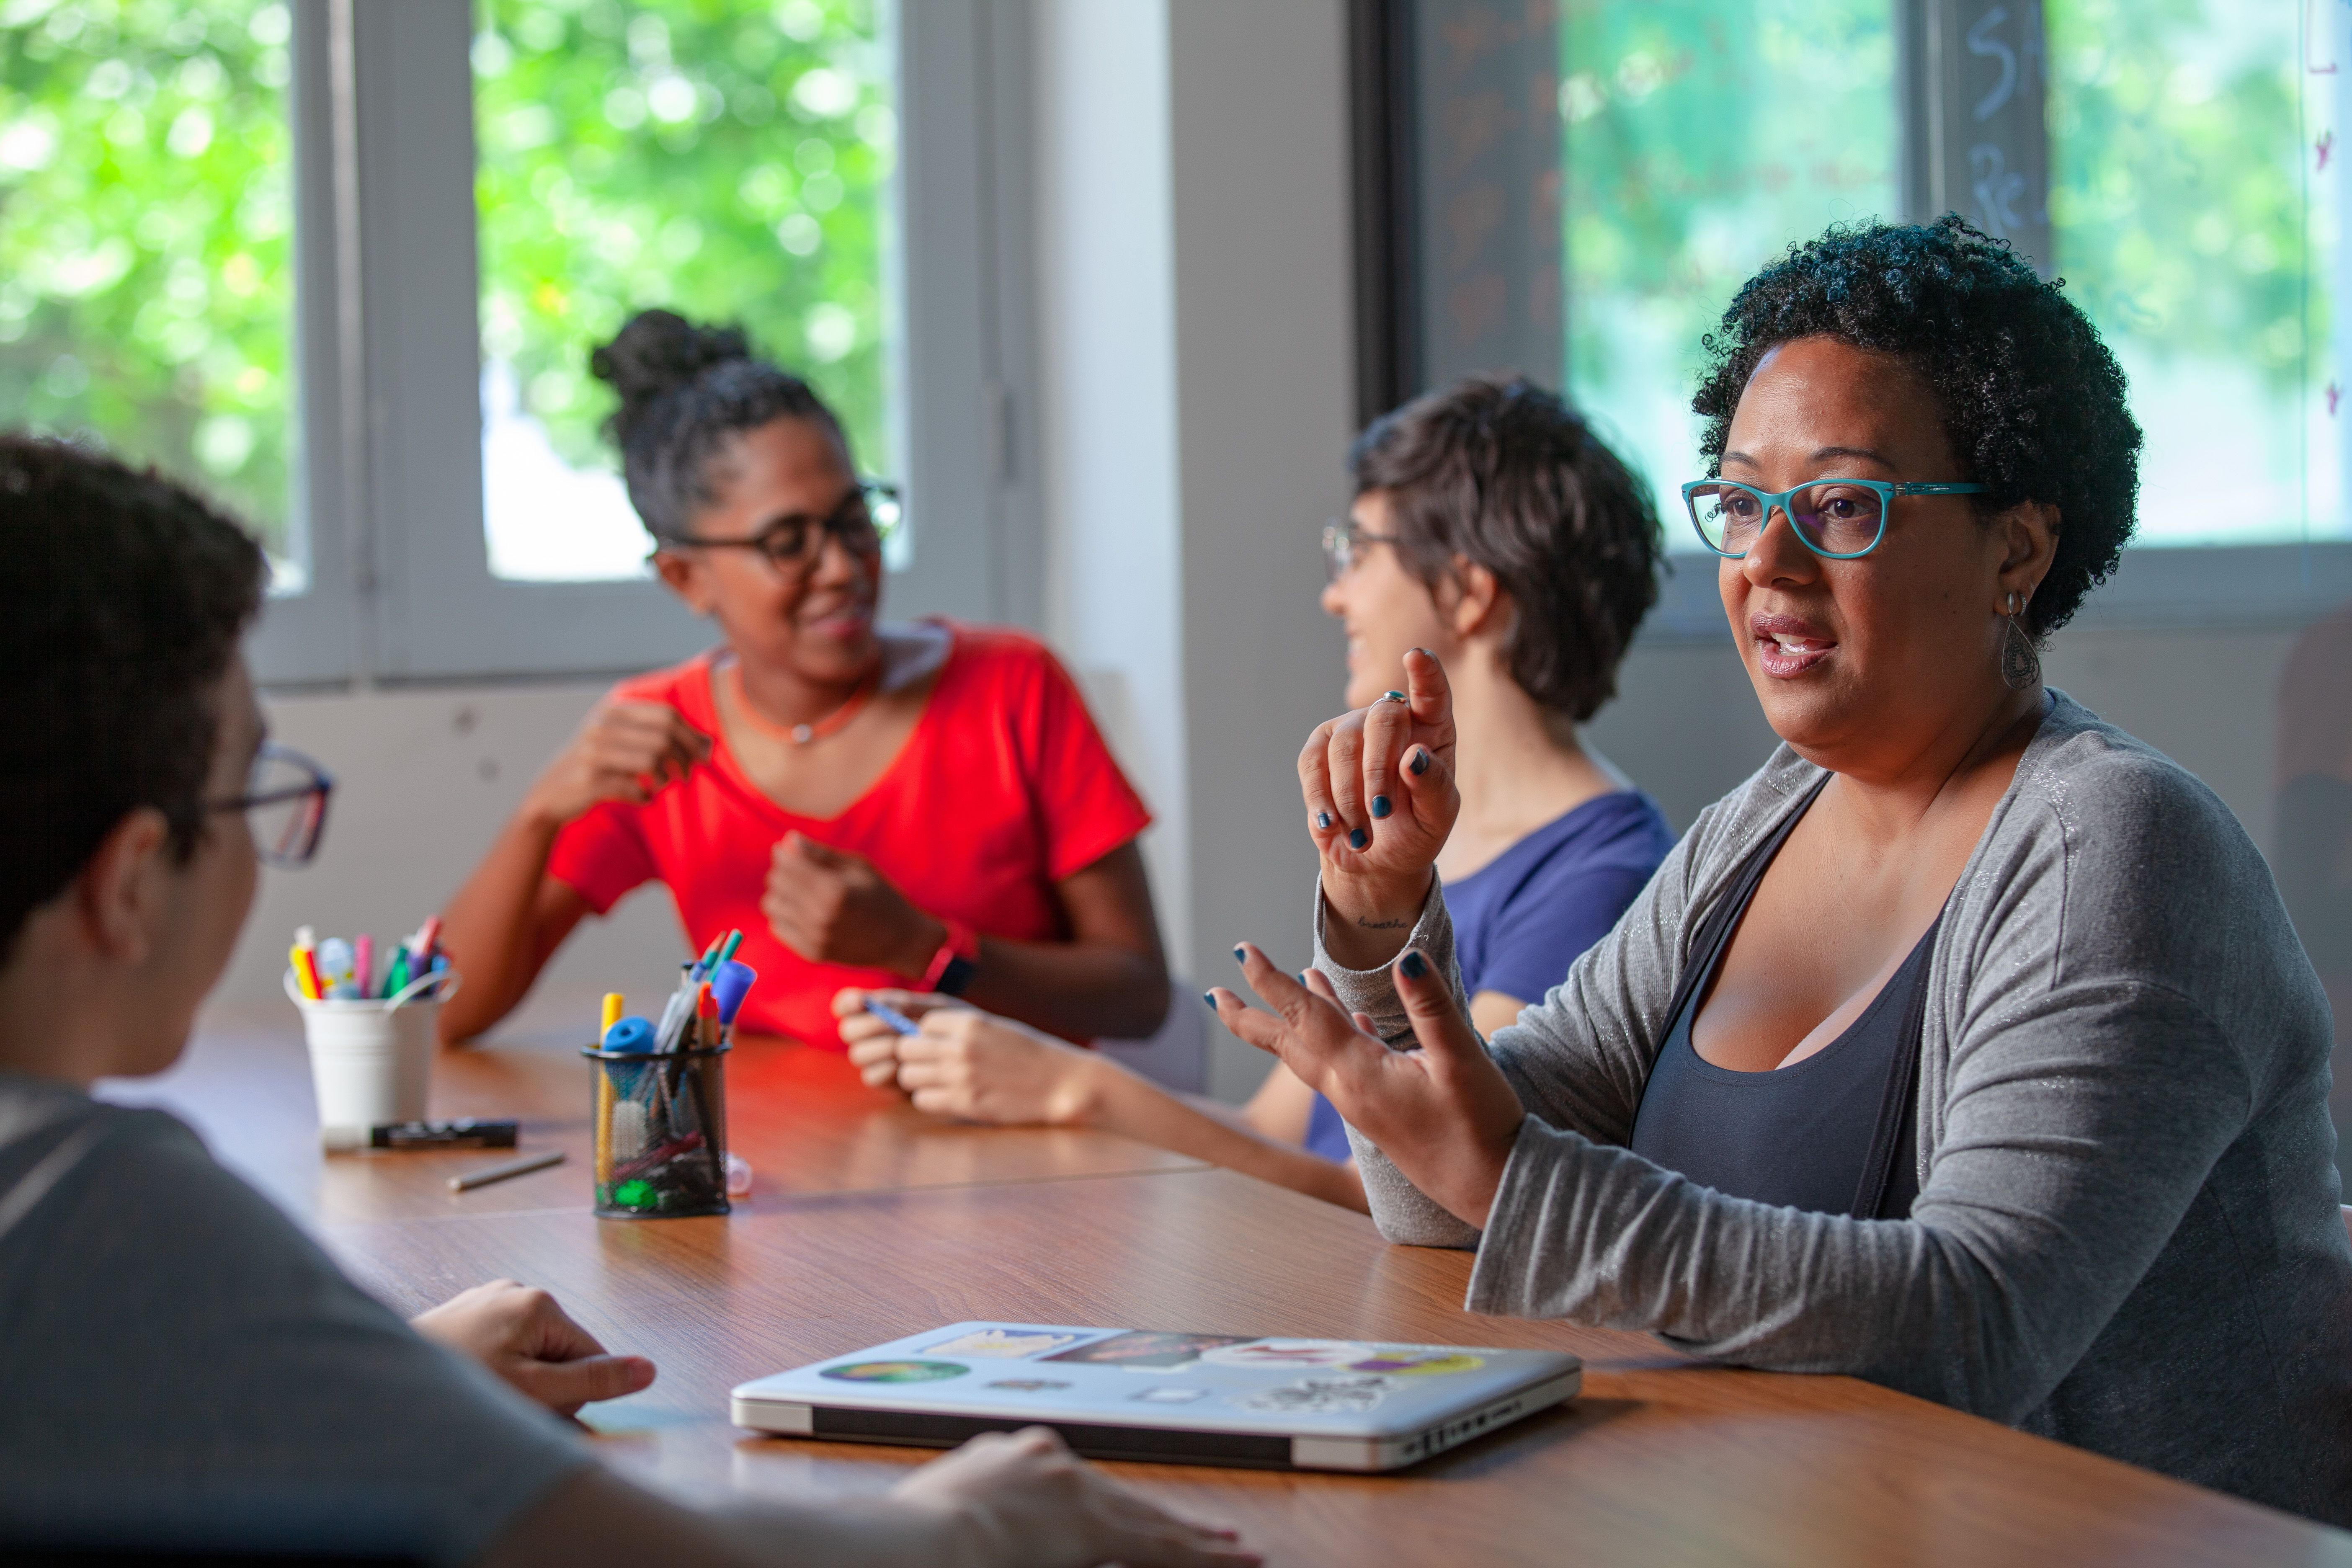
[{"left": 835, "top": 379, "right": 1672, "bottom": 1208}]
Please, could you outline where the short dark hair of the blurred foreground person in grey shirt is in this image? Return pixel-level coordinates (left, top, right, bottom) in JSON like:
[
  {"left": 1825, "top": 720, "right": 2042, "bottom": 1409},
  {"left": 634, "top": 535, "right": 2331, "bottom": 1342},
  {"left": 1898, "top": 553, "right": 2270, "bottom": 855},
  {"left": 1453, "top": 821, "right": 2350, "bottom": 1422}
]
[{"left": 0, "top": 435, "right": 266, "bottom": 959}]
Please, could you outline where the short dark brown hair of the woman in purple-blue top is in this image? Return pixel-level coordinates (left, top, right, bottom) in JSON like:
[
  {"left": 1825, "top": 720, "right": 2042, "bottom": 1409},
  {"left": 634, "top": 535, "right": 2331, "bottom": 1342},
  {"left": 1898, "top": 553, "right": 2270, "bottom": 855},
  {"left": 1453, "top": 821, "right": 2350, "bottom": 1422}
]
[{"left": 1348, "top": 376, "right": 1665, "bottom": 724}]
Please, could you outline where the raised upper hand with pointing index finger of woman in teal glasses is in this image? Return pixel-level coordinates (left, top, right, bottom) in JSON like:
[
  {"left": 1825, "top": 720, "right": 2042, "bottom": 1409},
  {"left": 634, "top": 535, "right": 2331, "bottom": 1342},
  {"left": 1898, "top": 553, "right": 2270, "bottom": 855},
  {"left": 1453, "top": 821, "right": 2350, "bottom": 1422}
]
[{"left": 1298, "top": 649, "right": 1461, "bottom": 969}]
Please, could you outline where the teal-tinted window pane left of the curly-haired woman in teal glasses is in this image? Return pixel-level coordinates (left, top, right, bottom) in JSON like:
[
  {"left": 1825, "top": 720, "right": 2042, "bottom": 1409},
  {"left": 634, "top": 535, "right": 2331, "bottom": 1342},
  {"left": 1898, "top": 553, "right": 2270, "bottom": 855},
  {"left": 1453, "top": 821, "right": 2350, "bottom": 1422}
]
[{"left": 1559, "top": 0, "right": 1901, "bottom": 550}]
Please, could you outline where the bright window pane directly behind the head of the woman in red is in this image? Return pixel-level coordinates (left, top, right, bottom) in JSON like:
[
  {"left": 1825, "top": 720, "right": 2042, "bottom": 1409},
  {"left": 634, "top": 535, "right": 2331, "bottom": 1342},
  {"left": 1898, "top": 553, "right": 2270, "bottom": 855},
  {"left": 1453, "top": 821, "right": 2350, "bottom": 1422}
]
[{"left": 473, "top": 0, "right": 896, "bottom": 580}]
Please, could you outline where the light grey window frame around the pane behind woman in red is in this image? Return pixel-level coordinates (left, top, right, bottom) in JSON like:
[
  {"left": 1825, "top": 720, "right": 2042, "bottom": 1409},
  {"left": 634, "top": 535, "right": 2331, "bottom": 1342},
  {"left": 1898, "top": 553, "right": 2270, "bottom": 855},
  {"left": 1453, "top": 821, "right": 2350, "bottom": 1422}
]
[{"left": 252, "top": 0, "right": 1042, "bottom": 686}]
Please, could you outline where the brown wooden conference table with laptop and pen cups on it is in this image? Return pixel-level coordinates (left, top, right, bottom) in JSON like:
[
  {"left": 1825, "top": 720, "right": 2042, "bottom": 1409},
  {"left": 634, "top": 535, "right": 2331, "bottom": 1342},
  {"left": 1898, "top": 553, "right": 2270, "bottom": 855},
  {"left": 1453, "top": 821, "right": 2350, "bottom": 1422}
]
[{"left": 108, "top": 1020, "right": 2352, "bottom": 1568}]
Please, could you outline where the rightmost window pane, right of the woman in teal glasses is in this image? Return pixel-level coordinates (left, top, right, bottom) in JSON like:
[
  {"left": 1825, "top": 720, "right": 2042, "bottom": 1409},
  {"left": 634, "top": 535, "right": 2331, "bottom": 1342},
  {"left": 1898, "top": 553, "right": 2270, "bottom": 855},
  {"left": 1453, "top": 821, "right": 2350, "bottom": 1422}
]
[{"left": 2046, "top": 0, "right": 2324, "bottom": 545}]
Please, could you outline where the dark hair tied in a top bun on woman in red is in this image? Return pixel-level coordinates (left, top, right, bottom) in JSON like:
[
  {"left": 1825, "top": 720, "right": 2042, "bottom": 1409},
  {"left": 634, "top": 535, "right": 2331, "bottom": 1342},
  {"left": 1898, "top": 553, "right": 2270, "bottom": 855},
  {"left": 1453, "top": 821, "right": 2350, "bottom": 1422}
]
[{"left": 588, "top": 310, "right": 849, "bottom": 541}]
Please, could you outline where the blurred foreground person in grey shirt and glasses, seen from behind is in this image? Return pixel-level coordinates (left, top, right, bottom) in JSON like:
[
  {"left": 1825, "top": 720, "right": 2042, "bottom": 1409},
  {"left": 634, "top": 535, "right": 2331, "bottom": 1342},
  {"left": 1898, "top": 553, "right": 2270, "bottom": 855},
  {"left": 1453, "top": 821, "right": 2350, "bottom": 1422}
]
[{"left": 0, "top": 437, "right": 1253, "bottom": 1568}]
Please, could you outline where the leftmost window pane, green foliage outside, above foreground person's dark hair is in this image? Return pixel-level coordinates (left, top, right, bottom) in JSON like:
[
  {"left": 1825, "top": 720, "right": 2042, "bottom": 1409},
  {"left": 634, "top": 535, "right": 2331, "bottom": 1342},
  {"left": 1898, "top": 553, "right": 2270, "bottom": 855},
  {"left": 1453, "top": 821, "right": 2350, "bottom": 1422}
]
[{"left": 0, "top": 0, "right": 301, "bottom": 576}]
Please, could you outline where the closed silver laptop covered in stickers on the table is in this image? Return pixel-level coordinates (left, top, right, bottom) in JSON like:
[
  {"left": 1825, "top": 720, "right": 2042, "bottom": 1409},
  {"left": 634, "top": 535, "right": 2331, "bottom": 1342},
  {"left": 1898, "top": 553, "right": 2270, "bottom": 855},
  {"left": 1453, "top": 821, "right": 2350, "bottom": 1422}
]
[{"left": 732, "top": 1323, "right": 1583, "bottom": 1469}]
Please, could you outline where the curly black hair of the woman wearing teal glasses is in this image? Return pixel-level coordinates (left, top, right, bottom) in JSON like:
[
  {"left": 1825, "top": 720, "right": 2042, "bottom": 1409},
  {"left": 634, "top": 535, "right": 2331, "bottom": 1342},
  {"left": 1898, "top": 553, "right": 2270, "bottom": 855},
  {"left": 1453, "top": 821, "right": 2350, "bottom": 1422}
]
[{"left": 1691, "top": 211, "right": 2141, "bottom": 637}]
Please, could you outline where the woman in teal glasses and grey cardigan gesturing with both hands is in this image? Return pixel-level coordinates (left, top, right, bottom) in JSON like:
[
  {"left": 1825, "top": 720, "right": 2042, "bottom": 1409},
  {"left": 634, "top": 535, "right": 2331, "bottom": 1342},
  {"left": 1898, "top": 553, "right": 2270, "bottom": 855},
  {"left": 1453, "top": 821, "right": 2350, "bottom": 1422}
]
[{"left": 1216, "top": 219, "right": 2352, "bottom": 1523}]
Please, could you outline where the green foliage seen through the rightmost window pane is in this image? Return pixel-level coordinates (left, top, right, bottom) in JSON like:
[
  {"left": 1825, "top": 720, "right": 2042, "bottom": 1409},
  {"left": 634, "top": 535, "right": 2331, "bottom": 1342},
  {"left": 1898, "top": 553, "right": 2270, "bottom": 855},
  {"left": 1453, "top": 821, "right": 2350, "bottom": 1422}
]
[{"left": 2046, "top": 0, "right": 2305, "bottom": 390}]
